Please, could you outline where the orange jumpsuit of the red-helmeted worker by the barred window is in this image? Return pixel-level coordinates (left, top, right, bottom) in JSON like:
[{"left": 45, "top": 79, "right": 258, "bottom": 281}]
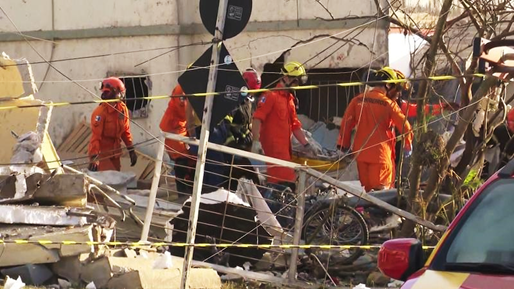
[{"left": 88, "top": 102, "right": 133, "bottom": 171}]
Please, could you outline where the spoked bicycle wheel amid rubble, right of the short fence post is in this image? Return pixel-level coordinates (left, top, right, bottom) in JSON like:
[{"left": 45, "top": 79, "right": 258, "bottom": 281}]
[{"left": 303, "top": 203, "right": 369, "bottom": 265}]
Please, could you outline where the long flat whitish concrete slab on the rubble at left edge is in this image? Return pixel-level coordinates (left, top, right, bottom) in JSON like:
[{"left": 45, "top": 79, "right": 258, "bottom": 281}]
[{"left": 0, "top": 205, "right": 91, "bottom": 226}]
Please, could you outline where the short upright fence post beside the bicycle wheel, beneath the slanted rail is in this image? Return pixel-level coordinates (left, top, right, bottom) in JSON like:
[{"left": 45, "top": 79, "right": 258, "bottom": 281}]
[{"left": 288, "top": 171, "right": 307, "bottom": 283}]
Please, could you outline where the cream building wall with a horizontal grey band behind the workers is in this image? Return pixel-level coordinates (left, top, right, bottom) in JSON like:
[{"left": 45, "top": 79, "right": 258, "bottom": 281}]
[{"left": 0, "top": 0, "right": 388, "bottom": 154}]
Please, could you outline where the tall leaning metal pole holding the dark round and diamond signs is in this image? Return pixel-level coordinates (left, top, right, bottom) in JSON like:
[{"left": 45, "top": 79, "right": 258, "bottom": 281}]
[{"left": 180, "top": 0, "right": 228, "bottom": 289}]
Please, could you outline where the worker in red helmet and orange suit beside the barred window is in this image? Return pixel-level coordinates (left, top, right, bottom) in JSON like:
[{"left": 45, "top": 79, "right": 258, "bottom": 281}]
[{"left": 88, "top": 77, "right": 137, "bottom": 171}]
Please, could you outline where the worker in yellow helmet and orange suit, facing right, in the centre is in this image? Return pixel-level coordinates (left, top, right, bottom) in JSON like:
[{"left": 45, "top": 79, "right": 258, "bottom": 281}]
[{"left": 252, "top": 62, "right": 319, "bottom": 191}]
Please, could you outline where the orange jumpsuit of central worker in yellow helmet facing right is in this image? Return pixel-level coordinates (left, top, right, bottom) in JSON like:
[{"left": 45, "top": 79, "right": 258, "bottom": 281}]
[{"left": 253, "top": 84, "right": 302, "bottom": 183}]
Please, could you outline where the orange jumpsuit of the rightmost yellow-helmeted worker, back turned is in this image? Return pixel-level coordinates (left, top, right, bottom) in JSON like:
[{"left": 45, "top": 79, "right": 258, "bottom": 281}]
[{"left": 338, "top": 89, "right": 412, "bottom": 192}]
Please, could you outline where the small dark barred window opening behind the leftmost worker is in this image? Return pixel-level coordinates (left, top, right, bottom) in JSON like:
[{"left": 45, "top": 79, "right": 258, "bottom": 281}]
[{"left": 120, "top": 77, "right": 152, "bottom": 119}]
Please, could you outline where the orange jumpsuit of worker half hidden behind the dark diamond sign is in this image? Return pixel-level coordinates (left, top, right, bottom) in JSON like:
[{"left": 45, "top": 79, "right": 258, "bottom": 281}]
[{"left": 159, "top": 85, "right": 189, "bottom": 160}]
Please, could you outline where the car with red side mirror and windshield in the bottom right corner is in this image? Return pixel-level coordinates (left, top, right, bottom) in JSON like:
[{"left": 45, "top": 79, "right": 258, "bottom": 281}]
[{"left": 378, "top": 160, "right": 514, "bottom": 289}]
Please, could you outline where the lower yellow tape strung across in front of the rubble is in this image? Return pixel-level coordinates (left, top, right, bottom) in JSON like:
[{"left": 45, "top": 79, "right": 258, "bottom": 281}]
[{"left": 0, "top": 239, "right": 434, "bottom": 250}]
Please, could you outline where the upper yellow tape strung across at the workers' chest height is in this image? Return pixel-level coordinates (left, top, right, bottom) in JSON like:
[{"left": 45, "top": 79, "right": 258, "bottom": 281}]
[{"left": 0, "top": 74, "right": 485, "bottom": 110}]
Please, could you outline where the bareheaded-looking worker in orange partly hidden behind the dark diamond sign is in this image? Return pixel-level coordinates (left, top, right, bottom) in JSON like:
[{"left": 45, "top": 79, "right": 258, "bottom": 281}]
[{"left": 159, "top": 85, "right": 195, "bottom": 195}]
